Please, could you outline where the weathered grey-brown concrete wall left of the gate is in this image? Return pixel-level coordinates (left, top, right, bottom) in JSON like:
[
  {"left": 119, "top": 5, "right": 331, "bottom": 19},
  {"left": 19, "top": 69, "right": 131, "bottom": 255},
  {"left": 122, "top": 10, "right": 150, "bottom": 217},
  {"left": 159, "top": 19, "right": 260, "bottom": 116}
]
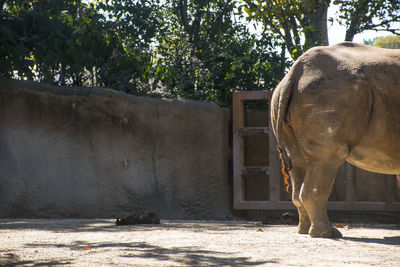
[{"left": 0, "top": 79, "right": 232, "bottom": 219}]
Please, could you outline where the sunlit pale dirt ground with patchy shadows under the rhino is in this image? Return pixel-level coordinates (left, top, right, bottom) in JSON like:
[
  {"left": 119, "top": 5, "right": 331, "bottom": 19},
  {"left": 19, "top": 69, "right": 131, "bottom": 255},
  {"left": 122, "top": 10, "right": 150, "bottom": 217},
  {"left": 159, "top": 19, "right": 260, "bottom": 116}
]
[{"left": 0, "top": 219, "right": 400, "bottom": 266}]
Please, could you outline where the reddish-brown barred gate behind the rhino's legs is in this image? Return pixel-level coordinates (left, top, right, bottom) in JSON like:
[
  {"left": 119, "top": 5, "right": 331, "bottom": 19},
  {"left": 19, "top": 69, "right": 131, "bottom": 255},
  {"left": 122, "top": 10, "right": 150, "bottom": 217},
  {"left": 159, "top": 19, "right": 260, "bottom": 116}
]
[{"left": 232, "top": 91, "right": 400, "bottom": 211}]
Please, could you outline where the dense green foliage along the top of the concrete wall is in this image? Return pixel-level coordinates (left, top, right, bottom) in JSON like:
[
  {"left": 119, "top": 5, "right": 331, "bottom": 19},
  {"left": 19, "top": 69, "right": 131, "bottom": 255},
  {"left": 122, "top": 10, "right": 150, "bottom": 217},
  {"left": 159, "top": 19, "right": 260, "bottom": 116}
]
[{"left": 0, "top": 0, "right": 286, "bottom": 106}]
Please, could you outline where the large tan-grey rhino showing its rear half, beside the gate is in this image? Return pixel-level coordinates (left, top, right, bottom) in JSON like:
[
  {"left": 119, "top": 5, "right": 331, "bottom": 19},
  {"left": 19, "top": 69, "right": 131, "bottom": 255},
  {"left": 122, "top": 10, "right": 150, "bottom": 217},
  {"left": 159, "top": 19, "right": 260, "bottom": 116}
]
[{"left": 271, "top": 42, "right": 400, "bottom": 237}]
